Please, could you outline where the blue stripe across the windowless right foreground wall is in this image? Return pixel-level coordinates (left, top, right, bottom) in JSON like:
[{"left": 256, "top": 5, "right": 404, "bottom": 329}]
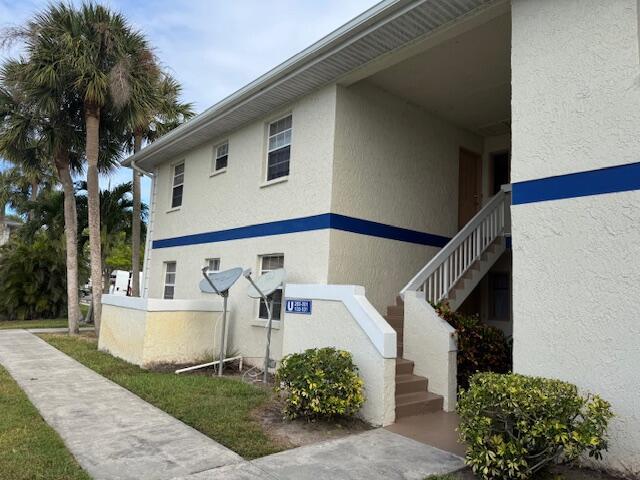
[{"left": 512, "top": 163, "right": 640, "bottom": 205}]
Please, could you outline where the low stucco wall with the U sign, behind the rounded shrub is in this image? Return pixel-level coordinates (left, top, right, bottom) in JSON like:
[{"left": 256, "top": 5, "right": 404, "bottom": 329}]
[{"left": 283, "top": 292, "right": 396, "bottom": 425}]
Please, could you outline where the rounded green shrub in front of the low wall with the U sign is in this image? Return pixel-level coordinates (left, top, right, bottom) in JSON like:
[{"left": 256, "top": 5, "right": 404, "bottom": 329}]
[{"left": 276, "top": 348, "right": 364, "bottom": 419}]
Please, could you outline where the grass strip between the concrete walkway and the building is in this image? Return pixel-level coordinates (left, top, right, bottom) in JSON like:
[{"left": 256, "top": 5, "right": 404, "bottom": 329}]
[{"left": 41, "top": 334, "right": 282, "bottom": 459}]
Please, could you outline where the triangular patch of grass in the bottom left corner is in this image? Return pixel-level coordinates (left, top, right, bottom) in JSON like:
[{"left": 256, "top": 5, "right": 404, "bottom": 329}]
[{"left": 0, "top": 367, "right": 91, "bottom": 480}]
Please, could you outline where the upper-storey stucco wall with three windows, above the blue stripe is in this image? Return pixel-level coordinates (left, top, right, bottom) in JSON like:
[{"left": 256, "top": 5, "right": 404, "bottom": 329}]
[{"left": 148, "top": 87, "right": 336, "bottom": 239}]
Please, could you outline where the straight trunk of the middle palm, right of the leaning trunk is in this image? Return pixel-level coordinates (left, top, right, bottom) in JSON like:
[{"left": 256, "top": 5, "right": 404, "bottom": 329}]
[{"left": 85, "top": 105, "right": 102, "bottom": 336}]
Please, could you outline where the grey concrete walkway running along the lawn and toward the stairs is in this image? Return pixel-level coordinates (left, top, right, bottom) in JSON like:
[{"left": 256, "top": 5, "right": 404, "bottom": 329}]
[{"left": 0, "top": 330, "right": 463, "bottom": 480}]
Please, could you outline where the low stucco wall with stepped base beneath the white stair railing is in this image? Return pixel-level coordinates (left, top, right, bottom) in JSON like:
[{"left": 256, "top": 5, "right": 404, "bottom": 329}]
[{"left": 403, "top": 291, "right": 458, "bottom": 412}]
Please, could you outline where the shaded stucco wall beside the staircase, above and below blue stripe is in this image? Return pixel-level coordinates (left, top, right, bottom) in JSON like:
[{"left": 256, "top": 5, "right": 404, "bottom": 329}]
[{"left": 329, "top": 82, "right": 483, "bottom": 309}]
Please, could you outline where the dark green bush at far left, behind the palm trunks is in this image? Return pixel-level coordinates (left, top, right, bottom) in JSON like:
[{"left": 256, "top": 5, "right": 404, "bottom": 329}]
[{"left": 0, "top": 235, "right": 67, "bottom": 320}]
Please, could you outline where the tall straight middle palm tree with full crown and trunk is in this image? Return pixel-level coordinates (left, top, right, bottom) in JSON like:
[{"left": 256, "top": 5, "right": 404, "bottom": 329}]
[{"left": 10, "top": 3, "right": 159, "bottom": 332}]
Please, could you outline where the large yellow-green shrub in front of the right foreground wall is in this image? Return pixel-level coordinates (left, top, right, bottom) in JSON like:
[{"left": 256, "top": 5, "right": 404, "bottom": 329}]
[{"left": 458, "top": 373, "right": 612, "bottom": 479}]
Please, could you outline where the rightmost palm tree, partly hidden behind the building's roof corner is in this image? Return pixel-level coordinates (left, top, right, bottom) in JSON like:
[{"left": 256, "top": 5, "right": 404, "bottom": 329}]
[{"left": 127, "top": 72, "right": 194, "bottom": 297}]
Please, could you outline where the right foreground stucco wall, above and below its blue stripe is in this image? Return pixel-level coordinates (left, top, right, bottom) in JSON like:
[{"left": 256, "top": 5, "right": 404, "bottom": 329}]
[{"left": 512, "top": 0, "right": 640, "bottom": 472}]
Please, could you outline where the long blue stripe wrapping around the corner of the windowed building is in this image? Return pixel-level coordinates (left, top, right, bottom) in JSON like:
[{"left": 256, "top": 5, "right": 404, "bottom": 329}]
[{"left": 152, "top": 213, "right": 450, "bottom": 249}]
